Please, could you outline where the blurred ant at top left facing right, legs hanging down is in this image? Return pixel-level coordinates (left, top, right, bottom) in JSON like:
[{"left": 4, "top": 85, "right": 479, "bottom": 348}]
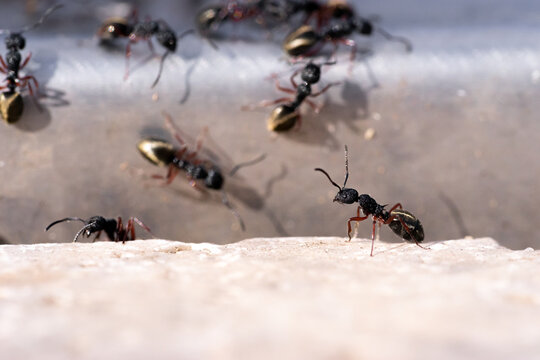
[{"left": 97, "top": 11, "right": 194, "bottom": 88}]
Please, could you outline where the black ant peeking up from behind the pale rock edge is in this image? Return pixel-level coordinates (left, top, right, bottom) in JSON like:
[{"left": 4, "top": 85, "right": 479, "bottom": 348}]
[{"left": 45, "top": 216, "right": 153, "bottom": 243}]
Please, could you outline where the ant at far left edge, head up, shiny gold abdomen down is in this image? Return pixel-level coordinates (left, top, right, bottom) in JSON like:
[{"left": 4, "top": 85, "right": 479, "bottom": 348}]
[{"left": 0, "top": 4, "right": 63, "bottom": 123}]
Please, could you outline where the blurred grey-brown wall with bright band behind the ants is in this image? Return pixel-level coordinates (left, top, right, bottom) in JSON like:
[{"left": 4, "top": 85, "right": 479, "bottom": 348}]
[{"left": 0, "top": 0, "right": 540, "bottom": 249}]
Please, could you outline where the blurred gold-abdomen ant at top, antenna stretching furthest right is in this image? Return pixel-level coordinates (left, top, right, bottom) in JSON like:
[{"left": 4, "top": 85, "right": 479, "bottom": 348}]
[{"left": 283, "top": 12, "right": 412, "bottom": 67}]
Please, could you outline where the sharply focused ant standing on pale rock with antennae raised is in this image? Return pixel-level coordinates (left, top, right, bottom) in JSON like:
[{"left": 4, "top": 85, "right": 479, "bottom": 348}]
[{"left": 315, "top": 145, "right": 425, "bottom": 256}]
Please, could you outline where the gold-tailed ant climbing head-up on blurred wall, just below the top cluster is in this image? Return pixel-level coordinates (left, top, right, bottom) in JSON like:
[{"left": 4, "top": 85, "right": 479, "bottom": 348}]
[{"left": 242, "top": 61, "right": 339, "bottom": 132}]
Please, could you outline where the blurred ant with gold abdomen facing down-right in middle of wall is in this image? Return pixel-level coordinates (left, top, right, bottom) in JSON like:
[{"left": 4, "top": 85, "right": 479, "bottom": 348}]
[{"left": 137, "top": 112, "right": 266, "bottom": 231}]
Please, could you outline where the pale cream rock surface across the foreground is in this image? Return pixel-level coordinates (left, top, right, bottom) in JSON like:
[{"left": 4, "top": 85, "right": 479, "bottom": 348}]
[{"left": 0, "top": 238, "right": 540, "bottom": 360}]
